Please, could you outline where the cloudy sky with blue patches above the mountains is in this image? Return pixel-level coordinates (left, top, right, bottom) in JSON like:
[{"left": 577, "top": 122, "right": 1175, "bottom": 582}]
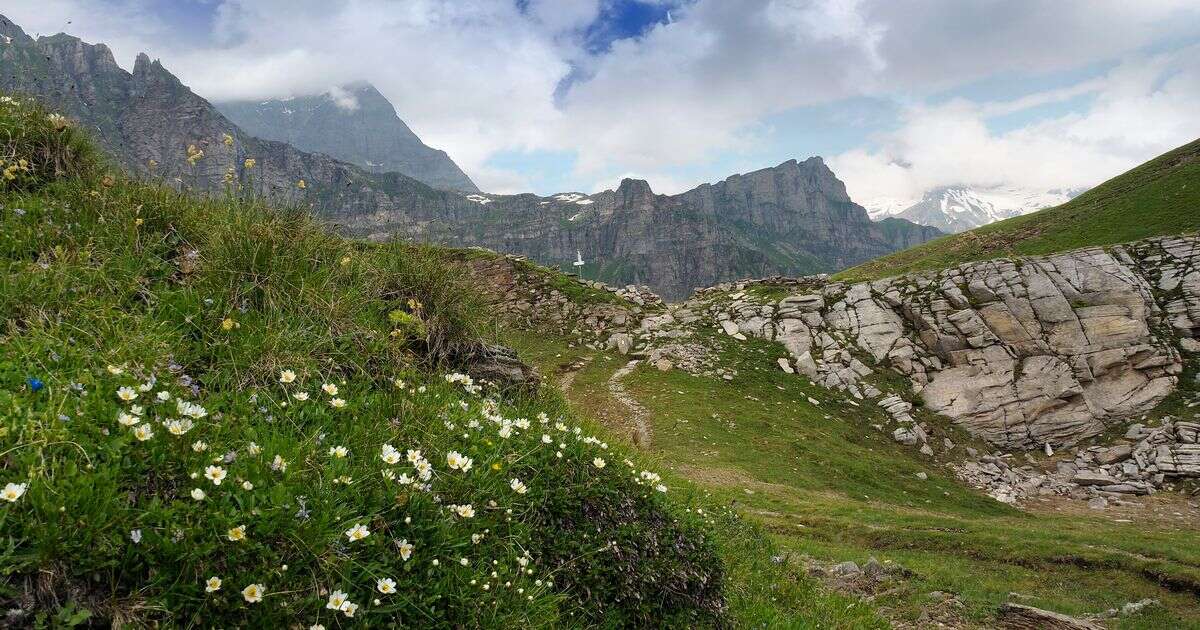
[{"left": 7, "top": 0, "right": 1200, "bottom": 208}]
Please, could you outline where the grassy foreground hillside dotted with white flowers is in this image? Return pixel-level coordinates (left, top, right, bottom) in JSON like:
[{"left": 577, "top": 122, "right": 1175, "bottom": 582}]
[{"left": 0, "top": 100, "right": 825, "bottom": 628}]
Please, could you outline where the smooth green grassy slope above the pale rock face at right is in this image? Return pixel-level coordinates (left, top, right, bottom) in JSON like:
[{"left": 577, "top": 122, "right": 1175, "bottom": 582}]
[{"left": 835, "top": 140, "right": 1200, "bottom": 281}]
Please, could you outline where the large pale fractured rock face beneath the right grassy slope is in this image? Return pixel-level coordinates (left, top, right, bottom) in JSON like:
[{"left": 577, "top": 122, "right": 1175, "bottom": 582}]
[{"left": 705, "top": 236, "right": 1200, "bottom": 448}]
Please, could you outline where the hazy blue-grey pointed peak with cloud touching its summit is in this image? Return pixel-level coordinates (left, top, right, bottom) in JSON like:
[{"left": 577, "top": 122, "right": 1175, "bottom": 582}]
[{"left": 216, "top": 83, "right": 479, "bottom": 192}]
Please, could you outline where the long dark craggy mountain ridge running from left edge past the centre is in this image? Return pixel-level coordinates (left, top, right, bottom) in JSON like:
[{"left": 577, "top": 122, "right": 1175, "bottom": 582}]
[{"left": 0, "top": 17, "right": 942, "bottom": 299}]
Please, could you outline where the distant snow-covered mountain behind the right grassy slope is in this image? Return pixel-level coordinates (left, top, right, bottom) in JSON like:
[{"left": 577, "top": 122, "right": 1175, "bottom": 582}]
[{"left": 868, "top": 186, "right": 1082, "bottom": 233}]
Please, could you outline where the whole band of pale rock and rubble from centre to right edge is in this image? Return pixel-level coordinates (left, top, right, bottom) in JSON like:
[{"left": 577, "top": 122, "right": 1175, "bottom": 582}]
[{"left": 472, "top": 236, "right": 1200, "bottom": 509}]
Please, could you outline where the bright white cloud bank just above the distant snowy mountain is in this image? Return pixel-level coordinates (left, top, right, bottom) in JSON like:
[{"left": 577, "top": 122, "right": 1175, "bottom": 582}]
[{"left": 830, "top": 46, "right": 1200, "bottom": 205}]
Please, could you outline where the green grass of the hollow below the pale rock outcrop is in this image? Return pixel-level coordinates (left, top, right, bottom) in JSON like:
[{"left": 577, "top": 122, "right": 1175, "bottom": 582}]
[{"left": 511, "top": 332, "right": 1200, "bottom": 628}]
